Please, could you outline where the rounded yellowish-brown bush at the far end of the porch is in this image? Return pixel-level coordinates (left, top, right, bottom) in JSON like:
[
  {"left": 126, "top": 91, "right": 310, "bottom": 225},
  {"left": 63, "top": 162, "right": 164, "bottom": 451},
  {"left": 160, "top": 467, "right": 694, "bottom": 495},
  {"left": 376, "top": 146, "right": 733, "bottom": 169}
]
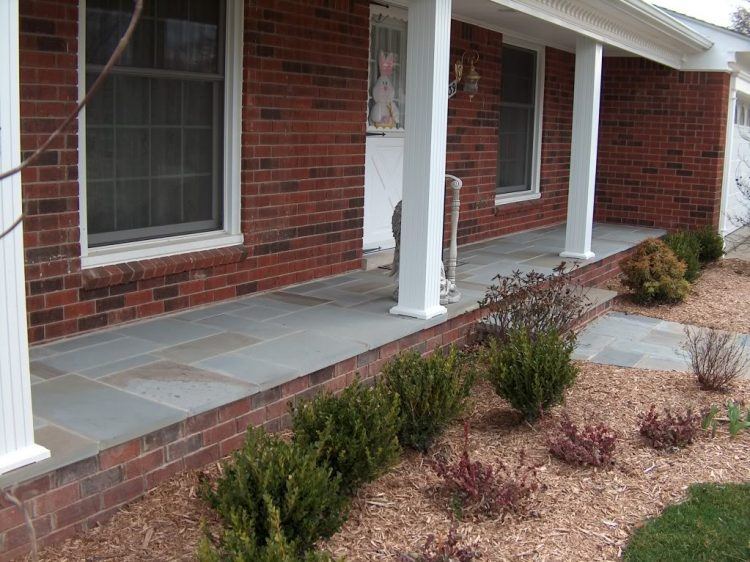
[{"left": 622, "top": 238, "right": 690, "bottom": 303}]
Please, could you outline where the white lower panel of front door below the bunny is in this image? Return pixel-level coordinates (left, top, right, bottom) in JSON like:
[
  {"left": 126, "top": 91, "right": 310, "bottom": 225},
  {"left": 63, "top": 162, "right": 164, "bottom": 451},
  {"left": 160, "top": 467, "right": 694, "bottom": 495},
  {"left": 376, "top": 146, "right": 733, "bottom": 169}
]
[{"left": 363, "top": 133, "right": 404, "bottom": 251}]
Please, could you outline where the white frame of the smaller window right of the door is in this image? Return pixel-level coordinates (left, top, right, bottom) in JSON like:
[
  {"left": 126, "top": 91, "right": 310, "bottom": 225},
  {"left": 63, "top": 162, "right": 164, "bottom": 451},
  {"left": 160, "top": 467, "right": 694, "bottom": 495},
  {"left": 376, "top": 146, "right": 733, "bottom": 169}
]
[{"left": 495, "top": 35, "right": 545, "bottom": 206}]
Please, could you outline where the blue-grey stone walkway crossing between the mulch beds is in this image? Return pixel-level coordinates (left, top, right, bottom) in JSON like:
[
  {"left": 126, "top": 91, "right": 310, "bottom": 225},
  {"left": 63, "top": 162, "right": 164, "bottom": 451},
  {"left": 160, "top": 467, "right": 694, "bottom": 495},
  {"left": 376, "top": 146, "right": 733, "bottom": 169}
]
[{"left": 574, "top": 312, "right": 750, "bottom": 376}]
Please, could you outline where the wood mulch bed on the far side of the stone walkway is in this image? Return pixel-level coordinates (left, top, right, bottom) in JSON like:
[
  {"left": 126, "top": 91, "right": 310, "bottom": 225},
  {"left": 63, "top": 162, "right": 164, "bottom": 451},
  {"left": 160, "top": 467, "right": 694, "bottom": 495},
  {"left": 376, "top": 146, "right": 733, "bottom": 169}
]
[{"left": 608, "top": 259, "right": 750, "bottom": 333}]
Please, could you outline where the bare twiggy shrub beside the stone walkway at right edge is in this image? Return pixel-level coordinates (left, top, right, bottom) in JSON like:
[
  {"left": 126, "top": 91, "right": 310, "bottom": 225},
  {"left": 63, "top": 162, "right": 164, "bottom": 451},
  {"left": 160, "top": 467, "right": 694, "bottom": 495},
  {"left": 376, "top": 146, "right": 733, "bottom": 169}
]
[{"left": 683, "top": 327, "right": 749, "bottom": 390}]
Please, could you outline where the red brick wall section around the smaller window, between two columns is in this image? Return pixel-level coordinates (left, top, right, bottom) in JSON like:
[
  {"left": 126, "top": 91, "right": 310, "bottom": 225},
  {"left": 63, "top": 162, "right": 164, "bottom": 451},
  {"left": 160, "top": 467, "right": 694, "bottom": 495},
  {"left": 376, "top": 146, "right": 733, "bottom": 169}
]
[{"left": 446, "top": 42, "right": 575, "bottom": 243}]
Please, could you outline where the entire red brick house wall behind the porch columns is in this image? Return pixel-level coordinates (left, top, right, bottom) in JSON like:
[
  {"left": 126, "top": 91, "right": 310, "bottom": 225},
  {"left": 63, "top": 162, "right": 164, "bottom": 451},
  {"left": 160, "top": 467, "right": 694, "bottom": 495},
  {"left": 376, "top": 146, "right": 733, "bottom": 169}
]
[{"left": 14, "top": 0, "right": 728, "bottom": 343}]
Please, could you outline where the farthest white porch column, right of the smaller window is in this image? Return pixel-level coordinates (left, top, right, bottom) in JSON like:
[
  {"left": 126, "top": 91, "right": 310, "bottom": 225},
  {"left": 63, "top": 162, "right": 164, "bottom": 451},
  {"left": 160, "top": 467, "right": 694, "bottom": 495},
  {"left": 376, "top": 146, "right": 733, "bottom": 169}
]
[{"left": 560, "top": 37, "right": 602, "bottom": 259}]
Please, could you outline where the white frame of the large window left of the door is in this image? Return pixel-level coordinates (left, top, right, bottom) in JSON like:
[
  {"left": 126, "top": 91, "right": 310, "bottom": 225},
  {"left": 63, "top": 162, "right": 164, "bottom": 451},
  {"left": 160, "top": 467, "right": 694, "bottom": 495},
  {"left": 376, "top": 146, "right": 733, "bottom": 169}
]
[{"left": 78, "top": 0, "right": 244, "bottom": 269}]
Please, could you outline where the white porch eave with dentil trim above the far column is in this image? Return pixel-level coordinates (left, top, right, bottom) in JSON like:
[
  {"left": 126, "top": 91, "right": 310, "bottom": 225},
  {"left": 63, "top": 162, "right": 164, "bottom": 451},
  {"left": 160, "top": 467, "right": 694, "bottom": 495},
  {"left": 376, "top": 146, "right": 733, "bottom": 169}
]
[{"left": 491, "top": 0, "right": 712, "bottom": 69}]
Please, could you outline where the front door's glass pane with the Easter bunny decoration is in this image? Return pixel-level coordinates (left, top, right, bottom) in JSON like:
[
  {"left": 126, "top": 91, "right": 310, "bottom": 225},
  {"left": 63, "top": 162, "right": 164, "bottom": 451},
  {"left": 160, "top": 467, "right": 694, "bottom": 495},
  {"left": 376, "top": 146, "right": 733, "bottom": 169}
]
[{"left": 368, "top": 16, "right": 406, "bottom": 129}]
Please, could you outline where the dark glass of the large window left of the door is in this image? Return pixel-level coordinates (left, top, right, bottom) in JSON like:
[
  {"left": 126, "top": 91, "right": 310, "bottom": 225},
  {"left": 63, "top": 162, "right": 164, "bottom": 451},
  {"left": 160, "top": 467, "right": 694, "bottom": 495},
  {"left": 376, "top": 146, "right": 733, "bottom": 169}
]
[{"left": 86, "top": 0, "right": 224, "bottom": 246}]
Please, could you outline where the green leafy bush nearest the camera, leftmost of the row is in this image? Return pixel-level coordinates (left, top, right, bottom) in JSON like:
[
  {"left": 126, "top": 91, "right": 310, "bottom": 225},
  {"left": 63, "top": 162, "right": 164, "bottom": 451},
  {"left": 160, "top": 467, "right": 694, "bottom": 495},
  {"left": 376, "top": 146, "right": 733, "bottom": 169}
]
[{"left": 203, "top": 428, "right": 348, "bottom": 554}]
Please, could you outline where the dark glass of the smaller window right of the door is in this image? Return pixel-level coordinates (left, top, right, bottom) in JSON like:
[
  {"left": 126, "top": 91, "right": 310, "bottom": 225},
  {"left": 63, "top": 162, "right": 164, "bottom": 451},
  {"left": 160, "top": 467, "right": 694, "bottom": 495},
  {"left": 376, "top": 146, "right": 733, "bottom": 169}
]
[{"left": 497, "top": 45, "right": 537, "bottom": 193}]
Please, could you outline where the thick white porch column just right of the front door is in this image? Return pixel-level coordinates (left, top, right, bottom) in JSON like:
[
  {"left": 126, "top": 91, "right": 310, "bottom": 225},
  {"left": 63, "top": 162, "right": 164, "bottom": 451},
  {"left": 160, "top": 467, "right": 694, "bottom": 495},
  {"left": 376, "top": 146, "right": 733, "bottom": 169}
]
[{"left": 391, "top": 0, "right": 451, "bottom": 319}]
